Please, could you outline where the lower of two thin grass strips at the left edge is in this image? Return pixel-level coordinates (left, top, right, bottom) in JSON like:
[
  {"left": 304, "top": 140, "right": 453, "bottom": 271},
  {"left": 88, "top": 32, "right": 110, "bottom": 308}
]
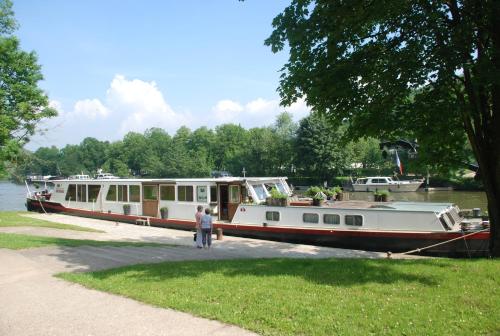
[{"left": 0, "top": 233, "right": 173, "bottom": 250}]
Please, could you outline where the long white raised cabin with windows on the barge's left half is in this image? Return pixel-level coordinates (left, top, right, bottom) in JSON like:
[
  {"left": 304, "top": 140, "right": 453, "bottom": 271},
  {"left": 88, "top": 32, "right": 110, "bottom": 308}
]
[{"left": 48, "top": 177, "right": 291, "bottom": 221}]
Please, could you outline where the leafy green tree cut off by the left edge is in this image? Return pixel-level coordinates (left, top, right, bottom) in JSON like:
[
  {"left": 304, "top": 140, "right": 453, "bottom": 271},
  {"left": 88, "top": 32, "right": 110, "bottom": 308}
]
[{"left": 0, "top": 0, "right": 57, "bottom": 173}]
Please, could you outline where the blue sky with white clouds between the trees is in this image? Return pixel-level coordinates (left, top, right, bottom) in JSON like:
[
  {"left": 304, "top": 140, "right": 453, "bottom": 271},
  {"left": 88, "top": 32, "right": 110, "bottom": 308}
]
[{"left": 14, "top": 0, "right": 309, "bottom": 150}]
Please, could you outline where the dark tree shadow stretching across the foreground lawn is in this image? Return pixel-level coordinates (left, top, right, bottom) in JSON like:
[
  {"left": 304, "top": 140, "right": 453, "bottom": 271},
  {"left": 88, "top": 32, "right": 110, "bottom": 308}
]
[{"left": 85, "top": 259, "right": 446, "bottom": 287}]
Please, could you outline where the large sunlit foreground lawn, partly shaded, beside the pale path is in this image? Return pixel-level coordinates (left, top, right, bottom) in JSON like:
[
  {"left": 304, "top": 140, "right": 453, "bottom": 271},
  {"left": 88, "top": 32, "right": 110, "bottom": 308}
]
[{"left": 58, "top": 259, "right": 500, "bottom": 335}]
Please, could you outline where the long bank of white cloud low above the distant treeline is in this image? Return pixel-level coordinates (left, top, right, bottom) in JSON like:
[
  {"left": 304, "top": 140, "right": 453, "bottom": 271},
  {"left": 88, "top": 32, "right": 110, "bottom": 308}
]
[{"left": 28, "top": 75, "right": 310, "bottom": 149}]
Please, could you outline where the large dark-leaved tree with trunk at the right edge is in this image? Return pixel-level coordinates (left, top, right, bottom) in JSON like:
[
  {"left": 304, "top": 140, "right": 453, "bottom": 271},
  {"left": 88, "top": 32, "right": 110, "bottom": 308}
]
[{"left": 266, "top": 0, "right": 500, "bottom": 257}]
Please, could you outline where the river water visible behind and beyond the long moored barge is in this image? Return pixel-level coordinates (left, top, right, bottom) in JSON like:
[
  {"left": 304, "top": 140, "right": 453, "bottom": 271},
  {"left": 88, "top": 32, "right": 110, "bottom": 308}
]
[{"left": 0, "top": 181, "right": 487, "bottom": 211}]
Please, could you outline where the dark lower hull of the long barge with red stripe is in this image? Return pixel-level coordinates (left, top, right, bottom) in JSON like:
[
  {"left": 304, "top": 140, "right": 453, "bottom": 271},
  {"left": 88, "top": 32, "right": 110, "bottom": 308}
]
[{"left": 28, "top": 199, "right": 490, "bottom": 255}]
